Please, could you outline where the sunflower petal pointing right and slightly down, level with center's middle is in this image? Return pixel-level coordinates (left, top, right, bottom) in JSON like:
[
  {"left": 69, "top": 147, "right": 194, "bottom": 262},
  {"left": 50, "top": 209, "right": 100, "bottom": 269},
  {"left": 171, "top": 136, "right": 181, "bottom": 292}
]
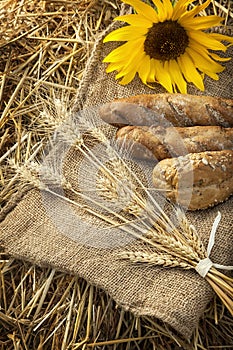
[{"left": 187, "top": 30, "right": 227, "bottom": 51}]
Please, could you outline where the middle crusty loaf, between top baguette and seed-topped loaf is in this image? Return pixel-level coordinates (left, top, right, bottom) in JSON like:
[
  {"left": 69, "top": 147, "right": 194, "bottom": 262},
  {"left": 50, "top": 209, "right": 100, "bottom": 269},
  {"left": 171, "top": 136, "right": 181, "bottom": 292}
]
[{"left": 116, "top": 126, "right": 233, "bottom": 161}]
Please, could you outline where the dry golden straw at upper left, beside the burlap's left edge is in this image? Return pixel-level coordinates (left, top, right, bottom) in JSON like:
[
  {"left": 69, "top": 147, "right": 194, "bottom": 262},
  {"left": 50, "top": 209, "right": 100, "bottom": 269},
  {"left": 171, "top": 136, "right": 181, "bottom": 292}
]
[{"left": 0, "top": 0, "right": 119, "bottom": 206}]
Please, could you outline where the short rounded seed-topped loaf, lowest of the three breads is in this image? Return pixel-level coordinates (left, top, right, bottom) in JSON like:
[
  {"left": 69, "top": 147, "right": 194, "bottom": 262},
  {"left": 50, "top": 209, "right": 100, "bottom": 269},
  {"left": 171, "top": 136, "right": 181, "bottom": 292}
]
[{"left": 153, "top": 150, "right": 233, "bottom": 210}]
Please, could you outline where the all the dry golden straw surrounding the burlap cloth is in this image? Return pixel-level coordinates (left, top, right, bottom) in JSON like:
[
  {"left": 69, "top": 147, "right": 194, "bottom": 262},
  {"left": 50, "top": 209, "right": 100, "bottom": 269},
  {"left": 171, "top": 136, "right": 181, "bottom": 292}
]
[{"left": 0, "top": 0, "right": 233, "bottom": 350}]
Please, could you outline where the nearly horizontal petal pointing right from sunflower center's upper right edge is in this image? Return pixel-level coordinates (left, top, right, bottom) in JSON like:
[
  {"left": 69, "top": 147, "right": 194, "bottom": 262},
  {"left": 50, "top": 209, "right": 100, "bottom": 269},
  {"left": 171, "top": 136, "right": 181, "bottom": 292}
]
[{"left": 178, "top": 15, "right": 223, "bottom": 31}]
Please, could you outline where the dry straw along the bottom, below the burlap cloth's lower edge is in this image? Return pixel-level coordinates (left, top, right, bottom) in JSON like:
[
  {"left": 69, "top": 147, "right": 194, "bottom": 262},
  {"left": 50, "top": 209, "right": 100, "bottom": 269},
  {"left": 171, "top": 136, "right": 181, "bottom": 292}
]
[{"left": 0, "top": 255, "right": 233, "bottom": 350}]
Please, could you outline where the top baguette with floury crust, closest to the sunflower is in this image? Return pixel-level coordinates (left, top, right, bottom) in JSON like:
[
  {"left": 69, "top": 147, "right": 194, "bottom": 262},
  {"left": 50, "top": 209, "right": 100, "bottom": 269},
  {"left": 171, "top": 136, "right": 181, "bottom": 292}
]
[{"left": 99, "top": 93, "right": 233, "bottom": 127}]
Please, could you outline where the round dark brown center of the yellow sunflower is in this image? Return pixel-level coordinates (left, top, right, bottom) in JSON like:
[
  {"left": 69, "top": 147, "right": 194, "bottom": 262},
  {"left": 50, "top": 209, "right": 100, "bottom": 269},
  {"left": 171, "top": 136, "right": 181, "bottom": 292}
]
[{"left": 144, "top": 20, "right": 189, "bottom": 61}]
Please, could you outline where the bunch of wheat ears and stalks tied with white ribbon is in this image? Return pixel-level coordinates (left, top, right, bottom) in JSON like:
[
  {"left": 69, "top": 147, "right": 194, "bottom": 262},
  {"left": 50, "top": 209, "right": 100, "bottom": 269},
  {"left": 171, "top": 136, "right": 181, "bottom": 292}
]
[{"left": 11, "top": 115, "right": 233, "bottom": 314}]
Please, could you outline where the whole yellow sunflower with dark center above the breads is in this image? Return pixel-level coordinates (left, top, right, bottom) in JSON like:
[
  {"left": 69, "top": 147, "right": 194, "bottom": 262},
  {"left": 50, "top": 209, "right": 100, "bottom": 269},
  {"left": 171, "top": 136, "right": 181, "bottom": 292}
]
[{"left": 103, "top": 0, "right": 233, "bottom": 93}]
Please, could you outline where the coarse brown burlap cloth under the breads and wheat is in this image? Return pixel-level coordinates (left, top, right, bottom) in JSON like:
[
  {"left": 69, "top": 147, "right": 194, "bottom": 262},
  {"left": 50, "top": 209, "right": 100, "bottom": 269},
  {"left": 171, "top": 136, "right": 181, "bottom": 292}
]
[{"left": 0, "top": 19, "right": 233, "bottom": 337}]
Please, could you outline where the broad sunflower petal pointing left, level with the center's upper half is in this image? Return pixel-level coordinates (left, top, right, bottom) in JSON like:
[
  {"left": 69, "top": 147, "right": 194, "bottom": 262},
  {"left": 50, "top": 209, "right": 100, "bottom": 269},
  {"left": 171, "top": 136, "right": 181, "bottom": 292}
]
[{"left": 103, "top": 26, "right": 148, "bottom": 43}]
